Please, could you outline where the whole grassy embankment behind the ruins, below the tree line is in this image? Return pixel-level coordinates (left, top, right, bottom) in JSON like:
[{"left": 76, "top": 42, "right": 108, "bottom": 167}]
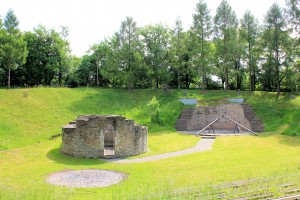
[{"left": 0, "top": 88, "right": 300, "bottom": 150}]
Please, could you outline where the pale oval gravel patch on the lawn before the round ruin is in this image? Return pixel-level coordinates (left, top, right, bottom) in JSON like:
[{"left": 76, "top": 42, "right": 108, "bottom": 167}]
[{"left": 47, "top": 169, "right": 126, "bottom": 188}]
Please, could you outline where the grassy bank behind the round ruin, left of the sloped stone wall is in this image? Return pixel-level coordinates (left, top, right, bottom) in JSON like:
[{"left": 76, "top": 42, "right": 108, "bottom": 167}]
[{"left": 0, "top": 88, "right": 182, "bottom": 150}]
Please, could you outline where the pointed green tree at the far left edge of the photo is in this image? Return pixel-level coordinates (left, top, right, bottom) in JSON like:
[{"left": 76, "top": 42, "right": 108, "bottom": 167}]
[{"left": 0, "top": 9, "right": 27, "bottom": 89}]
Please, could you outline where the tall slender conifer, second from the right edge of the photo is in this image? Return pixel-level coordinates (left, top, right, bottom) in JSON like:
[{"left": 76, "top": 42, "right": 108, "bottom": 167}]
[{"left": 263, "top": 3, "right": 289, "bottom": 96}]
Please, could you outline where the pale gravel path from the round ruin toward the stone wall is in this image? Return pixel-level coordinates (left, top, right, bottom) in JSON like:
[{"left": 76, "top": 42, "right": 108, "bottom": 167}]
[{"left": 102, "top": 138, "right": 215, "bottom": 163}]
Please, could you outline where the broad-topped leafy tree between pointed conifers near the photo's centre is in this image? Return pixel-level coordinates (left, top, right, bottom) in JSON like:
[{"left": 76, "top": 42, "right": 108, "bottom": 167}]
[{"left": 141, "top": 24, "right": 170, "bottom": 89}]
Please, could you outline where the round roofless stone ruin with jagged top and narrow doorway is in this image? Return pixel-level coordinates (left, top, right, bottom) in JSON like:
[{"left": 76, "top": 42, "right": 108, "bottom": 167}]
[{"left": 61, "top": 115, "right": 148, "bottom": 158}]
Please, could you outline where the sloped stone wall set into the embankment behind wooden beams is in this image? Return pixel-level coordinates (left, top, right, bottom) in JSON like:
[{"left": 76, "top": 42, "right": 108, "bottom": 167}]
[{"left": 176, "top": 104, "right": 264, "bottom": 132}]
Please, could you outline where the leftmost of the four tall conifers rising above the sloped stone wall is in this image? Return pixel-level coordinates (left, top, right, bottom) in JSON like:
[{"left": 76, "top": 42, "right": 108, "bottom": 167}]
[{"left": 192, "top": 0, "right": 213, "bottom": 90}]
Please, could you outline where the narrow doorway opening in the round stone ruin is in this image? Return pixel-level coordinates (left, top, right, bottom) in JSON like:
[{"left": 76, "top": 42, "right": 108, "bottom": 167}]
[{"left": 104, "top": 125, "right": 115, "bottom": 157}]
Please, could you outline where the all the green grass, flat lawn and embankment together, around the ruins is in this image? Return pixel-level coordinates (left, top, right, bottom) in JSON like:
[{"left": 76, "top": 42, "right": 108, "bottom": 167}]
[{"left": 0, "top": 88, "right": 300, "bottom": 200}]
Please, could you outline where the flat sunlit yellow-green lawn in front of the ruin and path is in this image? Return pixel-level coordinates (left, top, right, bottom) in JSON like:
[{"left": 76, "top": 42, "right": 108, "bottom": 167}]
[{"left": 0, "top": 134, "right": 300, "bottom": 199}]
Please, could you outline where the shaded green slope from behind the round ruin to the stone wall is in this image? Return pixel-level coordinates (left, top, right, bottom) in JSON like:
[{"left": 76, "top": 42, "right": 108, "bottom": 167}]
[{"left": 67, "top": 88, "right": 183, "bottom": 132}]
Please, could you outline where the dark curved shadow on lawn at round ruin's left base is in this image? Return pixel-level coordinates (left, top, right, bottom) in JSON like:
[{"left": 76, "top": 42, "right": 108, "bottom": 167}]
[{"left": 46, "top": 148, "right": 104, "bottom": 165}]
